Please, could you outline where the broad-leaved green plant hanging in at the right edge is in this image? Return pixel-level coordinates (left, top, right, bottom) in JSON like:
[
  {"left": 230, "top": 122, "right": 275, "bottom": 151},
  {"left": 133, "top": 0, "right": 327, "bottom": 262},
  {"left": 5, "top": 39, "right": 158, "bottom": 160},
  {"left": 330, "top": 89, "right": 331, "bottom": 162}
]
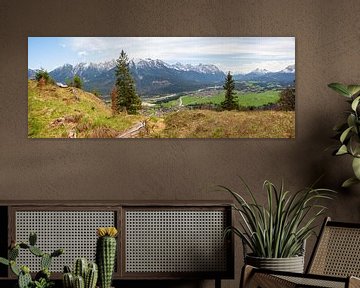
[{"left": 328, "top": 83, "right": 360, "bottom": 187}]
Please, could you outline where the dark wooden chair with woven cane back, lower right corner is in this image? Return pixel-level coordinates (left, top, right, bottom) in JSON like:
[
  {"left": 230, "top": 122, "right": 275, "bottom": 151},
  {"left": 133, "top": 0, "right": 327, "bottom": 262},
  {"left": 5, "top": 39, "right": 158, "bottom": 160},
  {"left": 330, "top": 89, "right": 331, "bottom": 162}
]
[{"left": 240, "top": 218, "right": 360, "bottom": 288}]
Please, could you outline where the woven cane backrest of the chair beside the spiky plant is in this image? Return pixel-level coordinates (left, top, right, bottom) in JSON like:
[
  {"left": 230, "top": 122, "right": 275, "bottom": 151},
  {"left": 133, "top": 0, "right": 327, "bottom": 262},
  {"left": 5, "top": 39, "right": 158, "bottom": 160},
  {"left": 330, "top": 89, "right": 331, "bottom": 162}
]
[{"left": 307, "top": 218, "right": 360, "bottom": 277}]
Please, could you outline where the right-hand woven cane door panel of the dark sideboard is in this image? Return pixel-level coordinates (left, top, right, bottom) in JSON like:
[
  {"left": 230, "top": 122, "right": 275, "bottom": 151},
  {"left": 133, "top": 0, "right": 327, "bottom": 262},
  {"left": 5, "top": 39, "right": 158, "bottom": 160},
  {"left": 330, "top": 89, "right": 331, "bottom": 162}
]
[{"left": 125, "top": 210, "right": 227, "bottom": 273}]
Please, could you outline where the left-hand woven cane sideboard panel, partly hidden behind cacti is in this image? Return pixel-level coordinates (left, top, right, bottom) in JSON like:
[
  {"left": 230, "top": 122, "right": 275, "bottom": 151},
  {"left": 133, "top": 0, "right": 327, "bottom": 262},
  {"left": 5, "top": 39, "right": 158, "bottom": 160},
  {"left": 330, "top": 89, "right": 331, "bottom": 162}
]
[{"left": 15, "top": 211, "right": 115, "bottom": 272}]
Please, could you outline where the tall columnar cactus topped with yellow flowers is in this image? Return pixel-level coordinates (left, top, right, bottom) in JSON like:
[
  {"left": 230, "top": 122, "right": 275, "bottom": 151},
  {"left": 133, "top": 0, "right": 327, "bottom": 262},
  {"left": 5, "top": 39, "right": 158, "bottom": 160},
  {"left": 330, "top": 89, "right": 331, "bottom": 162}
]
[{"left": 96, "top": 227, "right": 117, "bottom": 288}]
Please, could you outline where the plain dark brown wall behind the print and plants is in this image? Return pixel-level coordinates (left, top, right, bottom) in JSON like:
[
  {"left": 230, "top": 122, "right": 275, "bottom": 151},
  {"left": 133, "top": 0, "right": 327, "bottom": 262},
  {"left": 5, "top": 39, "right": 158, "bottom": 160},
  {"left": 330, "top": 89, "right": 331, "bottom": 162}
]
[{"left": 0, "top": 0, "right": 360, "bottom": 287}]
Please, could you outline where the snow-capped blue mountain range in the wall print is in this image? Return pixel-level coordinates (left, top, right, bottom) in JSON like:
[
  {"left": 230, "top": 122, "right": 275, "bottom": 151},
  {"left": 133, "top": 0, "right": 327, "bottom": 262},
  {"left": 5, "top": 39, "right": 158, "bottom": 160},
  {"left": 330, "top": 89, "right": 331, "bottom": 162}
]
[{"left": 28, "top": 58, "right": 295, "bottom": 98}]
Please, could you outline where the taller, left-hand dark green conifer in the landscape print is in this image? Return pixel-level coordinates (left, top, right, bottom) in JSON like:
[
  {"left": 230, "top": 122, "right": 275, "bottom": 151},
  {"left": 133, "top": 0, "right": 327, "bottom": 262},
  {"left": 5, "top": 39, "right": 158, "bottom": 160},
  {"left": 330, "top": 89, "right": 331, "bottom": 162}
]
[{"left": 114, "top": 50, "right": 141, "bottom": 114}]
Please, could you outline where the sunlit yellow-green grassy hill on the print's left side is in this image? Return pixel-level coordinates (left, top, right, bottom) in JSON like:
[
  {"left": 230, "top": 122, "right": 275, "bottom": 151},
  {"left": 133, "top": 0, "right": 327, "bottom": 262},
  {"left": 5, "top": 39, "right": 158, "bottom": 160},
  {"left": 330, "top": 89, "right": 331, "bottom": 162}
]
[{"left": 28, "top": 80, "right": 144, "bottom": 138}]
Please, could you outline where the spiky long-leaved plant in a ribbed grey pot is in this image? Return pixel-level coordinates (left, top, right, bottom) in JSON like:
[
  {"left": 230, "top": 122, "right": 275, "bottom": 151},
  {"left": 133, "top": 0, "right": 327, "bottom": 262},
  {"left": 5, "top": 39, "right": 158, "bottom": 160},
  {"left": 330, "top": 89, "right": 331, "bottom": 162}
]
[{"left": 220, "top": 180, "right": 334, "bottom": 273}]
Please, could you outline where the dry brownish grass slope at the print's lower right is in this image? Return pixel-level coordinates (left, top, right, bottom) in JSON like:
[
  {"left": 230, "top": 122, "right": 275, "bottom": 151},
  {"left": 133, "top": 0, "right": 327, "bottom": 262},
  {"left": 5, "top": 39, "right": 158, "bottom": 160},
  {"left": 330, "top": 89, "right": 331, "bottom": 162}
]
[{"left": 151, "top": 110, "right": 295, "bottom": 138}]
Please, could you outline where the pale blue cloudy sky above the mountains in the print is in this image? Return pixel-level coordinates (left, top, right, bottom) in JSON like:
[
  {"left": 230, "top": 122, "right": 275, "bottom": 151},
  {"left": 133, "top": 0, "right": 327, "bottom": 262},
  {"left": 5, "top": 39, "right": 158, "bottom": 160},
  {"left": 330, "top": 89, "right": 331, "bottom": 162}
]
[{"left": 28, "top": 37, "right": 295, "bottom": 73}]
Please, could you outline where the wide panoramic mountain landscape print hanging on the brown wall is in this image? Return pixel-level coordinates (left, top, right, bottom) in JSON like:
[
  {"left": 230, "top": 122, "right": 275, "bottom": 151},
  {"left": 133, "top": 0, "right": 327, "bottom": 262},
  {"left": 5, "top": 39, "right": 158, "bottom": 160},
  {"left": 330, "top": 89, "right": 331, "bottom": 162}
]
[{"left": 28, "top": 37, "right": 295, "bottom": 138}]
